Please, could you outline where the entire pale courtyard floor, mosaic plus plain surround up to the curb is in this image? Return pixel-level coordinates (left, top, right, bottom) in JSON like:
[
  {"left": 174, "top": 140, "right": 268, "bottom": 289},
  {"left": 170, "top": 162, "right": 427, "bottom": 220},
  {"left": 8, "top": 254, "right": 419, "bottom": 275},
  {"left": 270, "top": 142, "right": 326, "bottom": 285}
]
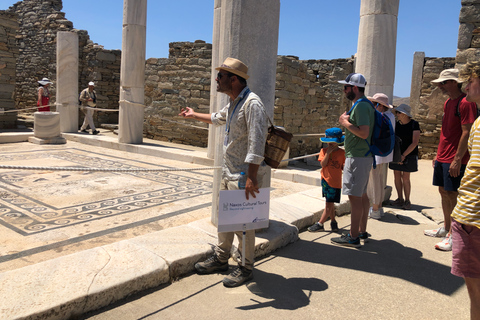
[{"left": 0, "top": 141, "right": 311, "bottom": 272}]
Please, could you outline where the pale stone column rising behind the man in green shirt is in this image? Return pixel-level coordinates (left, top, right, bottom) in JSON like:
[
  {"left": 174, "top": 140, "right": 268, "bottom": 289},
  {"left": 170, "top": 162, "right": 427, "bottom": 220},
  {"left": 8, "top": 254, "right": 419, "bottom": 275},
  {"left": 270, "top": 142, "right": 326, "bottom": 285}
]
[{"left": 355, "top": 0, "right": 399, "bottom": 103}]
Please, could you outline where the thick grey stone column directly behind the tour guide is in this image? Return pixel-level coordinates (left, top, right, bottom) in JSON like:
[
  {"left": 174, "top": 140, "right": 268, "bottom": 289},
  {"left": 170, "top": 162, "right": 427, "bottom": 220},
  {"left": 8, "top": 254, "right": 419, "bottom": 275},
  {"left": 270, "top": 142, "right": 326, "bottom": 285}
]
[{"left": 212, "top": 0, "right": 280, "bottom": 225}]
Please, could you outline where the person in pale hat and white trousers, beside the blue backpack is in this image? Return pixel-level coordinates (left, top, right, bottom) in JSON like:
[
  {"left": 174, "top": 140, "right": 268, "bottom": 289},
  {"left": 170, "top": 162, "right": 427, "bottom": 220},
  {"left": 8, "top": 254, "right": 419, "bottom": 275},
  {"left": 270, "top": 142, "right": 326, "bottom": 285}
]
[{"left": 367, "top": 93, "right": 395, "bottom": 219}]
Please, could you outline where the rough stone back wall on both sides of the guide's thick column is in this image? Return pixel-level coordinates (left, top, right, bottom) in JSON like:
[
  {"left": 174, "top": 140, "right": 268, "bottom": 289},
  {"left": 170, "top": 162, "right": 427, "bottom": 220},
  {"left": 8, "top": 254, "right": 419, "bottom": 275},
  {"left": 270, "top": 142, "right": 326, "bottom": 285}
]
[{"left": 145, "top": 48, "right": 353, "bottom": 156}]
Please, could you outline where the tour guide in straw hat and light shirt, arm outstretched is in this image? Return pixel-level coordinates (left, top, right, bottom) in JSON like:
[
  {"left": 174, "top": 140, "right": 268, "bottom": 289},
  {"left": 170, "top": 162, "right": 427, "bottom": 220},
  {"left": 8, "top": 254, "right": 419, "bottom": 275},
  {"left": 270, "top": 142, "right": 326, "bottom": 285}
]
[{"left": 180, "top": 58, "right": 268, "bottom": 287}]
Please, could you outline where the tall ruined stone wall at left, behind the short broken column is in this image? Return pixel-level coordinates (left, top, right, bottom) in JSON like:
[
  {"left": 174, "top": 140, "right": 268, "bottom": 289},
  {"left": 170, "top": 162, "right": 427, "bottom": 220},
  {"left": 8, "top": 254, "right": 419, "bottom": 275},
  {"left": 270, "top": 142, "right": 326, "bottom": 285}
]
[{"left": 7, "top": 0, "right": 120, "bottom": 124}]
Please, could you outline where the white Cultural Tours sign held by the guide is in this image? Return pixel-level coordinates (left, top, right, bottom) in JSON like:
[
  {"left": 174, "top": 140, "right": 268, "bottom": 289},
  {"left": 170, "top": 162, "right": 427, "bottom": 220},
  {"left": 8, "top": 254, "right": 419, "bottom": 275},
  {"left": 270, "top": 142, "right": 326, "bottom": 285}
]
[{"left": 218, "top": 188, "right": 270, "bottom": 232}]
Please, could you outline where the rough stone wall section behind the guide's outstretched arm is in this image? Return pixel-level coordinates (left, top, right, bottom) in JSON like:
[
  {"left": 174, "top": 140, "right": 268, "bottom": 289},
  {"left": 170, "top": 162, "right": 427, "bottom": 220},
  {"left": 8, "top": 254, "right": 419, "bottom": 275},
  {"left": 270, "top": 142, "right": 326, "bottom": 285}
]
[{"left": 144, "top": 40, "right": 212, "bottom": 147}]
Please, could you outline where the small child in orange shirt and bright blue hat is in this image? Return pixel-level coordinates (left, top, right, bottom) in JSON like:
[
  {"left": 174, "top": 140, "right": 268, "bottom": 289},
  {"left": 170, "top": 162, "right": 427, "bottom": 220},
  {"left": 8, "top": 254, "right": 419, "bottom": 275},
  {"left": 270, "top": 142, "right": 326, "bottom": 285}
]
[{"left": 308, "top": 128, "right": 345, "bottom": 232}]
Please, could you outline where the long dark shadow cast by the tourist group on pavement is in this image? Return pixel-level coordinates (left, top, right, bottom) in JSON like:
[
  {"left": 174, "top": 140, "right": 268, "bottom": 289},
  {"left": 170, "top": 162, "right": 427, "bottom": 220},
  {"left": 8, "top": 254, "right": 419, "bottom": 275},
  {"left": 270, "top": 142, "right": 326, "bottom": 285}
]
[{"left": 256, "top": 234, "right": 464, "bottom": 295}]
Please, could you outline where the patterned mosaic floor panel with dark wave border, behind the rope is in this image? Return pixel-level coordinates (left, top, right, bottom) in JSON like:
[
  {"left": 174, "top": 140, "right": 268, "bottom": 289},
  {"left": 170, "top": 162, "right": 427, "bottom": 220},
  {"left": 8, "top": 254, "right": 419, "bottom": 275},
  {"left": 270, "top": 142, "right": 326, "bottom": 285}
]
[{"left": 0, "top": 149, "right": 212, "bottom": 236}]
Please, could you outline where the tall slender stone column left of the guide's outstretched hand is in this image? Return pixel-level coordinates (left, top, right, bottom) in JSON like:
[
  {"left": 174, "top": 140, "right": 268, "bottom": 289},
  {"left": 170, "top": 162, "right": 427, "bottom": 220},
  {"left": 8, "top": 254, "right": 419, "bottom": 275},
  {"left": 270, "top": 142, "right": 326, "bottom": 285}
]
[{"left": 118, "top": 0, "right": 147, "bottom": 143}]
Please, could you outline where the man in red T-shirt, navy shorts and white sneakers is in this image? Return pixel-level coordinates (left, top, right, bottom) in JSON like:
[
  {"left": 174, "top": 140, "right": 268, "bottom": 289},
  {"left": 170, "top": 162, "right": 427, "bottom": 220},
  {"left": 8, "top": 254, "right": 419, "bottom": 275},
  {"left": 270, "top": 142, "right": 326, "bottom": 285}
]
[{"left": 424, "top": 69, "right": 477, "bottom": 251}]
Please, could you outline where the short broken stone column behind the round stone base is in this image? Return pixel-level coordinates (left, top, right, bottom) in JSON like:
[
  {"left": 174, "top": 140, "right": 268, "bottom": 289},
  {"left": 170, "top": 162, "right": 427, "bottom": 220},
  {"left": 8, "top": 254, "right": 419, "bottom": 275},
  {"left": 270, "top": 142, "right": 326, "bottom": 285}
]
[{"left": 56, "top": 31, "right": 78, "bottom": 132}]
